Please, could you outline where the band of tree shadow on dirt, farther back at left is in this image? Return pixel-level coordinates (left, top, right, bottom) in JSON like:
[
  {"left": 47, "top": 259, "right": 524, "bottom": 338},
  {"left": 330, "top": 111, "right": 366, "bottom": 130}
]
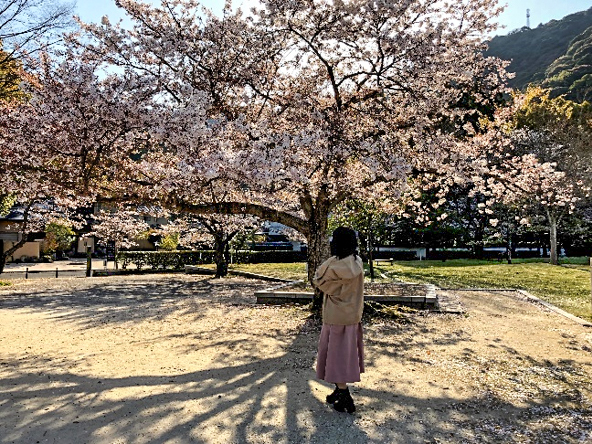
[{"left": 0, "top": 275, "right": 262, "bottom": 328}]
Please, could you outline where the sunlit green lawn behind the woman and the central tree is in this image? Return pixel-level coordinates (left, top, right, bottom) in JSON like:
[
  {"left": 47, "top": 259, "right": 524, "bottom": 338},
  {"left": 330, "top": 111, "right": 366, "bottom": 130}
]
[{"left": 233, "top": 258, "right": 592, "bottom": 320}]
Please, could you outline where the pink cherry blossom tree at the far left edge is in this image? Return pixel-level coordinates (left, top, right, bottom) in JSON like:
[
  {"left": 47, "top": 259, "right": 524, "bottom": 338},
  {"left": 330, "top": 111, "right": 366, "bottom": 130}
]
[{"left": 0, "top": 45, "right": 164, "bottom": 268}]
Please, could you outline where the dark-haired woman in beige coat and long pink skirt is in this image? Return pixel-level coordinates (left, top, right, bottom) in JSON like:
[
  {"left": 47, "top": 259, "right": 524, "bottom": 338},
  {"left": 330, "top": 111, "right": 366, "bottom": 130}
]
[{"left": 313, "top": 227, "right": 364, "bottom": 413}]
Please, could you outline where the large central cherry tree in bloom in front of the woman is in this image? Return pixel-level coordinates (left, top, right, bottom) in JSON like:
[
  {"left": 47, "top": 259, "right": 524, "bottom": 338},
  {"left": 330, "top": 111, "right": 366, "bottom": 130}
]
[{"left": 75, "top": 0, "right": 540, "bottom": 288}]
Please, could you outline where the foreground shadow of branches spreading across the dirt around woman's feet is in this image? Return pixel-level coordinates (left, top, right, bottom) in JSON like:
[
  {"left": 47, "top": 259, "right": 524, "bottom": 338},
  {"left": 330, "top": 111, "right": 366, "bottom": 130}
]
[{"left": 0, "top": 326, "right": 592, "bottom": 443}]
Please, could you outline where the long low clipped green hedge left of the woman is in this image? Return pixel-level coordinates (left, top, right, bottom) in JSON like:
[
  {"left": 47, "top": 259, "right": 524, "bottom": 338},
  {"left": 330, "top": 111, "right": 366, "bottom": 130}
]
[{"left": 117, "top": 250, "right": 306, "bottom": 270}]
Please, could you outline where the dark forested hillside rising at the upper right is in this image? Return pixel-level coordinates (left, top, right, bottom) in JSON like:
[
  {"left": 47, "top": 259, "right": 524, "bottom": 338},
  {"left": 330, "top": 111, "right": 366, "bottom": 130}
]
[{"left": 487, "top": 8, "right": 592, "bottom": 102}]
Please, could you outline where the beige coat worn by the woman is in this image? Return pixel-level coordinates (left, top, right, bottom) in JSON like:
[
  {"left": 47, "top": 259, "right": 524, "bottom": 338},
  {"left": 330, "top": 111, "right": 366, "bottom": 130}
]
[{"left": 313, "top": 255, "right": 364, "bottom": 325}]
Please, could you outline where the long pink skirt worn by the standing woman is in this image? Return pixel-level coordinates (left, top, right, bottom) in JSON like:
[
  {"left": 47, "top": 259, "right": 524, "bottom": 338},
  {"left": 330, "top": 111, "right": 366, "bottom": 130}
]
[{"left": 317, "top": 324, "right": 364, "bottom": 384}]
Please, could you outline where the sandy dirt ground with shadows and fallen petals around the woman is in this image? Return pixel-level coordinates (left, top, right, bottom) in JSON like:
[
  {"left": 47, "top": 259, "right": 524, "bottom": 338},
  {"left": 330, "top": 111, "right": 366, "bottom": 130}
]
[{"left": 0, "top": 275, "right": 592, "bottom": 444}]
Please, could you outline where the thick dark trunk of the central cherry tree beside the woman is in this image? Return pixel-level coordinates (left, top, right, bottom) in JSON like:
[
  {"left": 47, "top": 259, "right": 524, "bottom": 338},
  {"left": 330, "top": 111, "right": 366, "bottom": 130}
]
[{"left": 307, "top": 211, "right": 330, "bottom": 315}]
